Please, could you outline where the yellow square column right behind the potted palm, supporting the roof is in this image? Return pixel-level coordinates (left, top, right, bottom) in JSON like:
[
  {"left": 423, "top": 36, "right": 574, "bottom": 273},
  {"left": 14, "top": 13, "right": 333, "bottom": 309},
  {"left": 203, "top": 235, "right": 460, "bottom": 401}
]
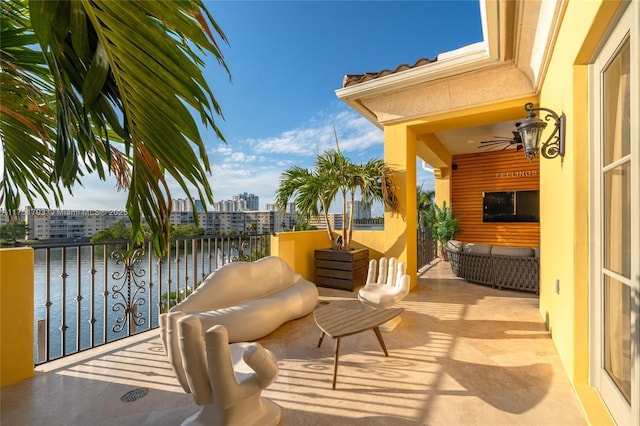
[{"left": 384, "top": 125, "right": 418, "bottom": 288}]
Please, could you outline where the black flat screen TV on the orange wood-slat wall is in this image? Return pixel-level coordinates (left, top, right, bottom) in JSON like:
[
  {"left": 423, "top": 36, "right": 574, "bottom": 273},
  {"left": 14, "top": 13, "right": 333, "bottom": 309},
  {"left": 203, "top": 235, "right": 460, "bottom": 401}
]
[{"left": 482, "top": 190, "right": 540, "bottom": 222}]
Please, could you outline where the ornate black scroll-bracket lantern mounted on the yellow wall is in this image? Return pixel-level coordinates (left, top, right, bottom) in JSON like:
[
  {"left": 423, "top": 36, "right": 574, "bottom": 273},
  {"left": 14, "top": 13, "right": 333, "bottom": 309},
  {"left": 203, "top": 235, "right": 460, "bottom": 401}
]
[{"left": 517, "top": 102, "right": 566, "bottom": 161}]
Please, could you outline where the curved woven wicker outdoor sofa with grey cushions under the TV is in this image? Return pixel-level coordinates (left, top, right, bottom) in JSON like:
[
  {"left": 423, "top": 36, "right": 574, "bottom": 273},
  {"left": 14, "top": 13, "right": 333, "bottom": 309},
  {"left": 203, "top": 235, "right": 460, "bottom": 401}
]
[{"left": 446, "top": 240, "right": 540, "bottom": 294}]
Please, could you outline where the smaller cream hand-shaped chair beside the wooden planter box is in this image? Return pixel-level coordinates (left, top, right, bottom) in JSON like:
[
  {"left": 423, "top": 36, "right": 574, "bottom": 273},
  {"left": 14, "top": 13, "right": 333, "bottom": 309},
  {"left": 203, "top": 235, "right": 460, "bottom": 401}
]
[{"left": 358, "top": 257, "right": 409, "bottom": 332}]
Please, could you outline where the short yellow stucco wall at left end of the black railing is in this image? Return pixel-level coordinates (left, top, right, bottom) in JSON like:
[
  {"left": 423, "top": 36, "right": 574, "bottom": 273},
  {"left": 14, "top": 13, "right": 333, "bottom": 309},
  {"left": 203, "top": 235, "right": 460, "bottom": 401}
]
[{"left": 0, "top": 248, "right": 33, "bottom": 387}]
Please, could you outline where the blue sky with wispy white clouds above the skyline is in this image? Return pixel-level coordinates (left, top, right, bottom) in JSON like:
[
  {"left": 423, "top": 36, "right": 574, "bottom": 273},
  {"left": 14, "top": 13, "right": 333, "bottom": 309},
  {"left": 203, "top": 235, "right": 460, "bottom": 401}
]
[{"left": 50, "top": 0, "right": 482, "bottom": 215}]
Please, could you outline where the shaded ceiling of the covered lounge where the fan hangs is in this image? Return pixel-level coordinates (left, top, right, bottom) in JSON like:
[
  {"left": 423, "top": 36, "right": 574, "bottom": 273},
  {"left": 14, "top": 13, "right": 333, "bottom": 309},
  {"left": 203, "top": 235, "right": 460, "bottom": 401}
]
[{"left": 435, "top": 114, "right": 525, "bottom": 155}]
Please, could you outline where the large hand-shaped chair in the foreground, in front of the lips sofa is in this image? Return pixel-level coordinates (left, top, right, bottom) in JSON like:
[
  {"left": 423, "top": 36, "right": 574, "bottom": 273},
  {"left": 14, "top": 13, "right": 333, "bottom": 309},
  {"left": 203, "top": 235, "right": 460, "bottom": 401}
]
[{"left": 178, "top": 315, "right": 280, "bottom": 426}]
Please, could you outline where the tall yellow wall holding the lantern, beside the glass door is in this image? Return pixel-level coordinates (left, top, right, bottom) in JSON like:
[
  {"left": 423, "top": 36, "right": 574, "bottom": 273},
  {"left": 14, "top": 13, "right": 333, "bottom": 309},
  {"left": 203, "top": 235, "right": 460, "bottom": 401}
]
[{"left": 540, "top": 1, "right": 620, "bottom": 424}]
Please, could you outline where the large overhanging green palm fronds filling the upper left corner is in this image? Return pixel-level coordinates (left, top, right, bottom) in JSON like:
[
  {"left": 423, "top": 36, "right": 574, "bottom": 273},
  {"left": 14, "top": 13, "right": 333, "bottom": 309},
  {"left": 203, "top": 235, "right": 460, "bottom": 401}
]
[{"left": 0, "top": 0, "right": 230, "bottom": 254}]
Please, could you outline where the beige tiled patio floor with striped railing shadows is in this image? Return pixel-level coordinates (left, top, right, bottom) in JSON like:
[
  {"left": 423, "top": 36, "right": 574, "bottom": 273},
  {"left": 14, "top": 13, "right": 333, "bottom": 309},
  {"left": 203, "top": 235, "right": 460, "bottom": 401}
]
[{"left": 0, "top": 262, "right": 587, "bottom": 426}]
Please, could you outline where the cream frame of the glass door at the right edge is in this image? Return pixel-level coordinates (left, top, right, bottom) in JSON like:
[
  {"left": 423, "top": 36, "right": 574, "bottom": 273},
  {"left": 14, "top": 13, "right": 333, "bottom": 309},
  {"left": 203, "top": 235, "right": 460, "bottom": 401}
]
[{"left": 589, "top": 0, "right": 640, "bottom": 424}]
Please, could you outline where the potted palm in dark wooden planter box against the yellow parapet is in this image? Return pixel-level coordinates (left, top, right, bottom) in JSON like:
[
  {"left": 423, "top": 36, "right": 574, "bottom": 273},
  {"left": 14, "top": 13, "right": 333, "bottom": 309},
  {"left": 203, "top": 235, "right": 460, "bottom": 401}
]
[{"left": 275, "top": 129, "right": 398, "bottom": 290}]
